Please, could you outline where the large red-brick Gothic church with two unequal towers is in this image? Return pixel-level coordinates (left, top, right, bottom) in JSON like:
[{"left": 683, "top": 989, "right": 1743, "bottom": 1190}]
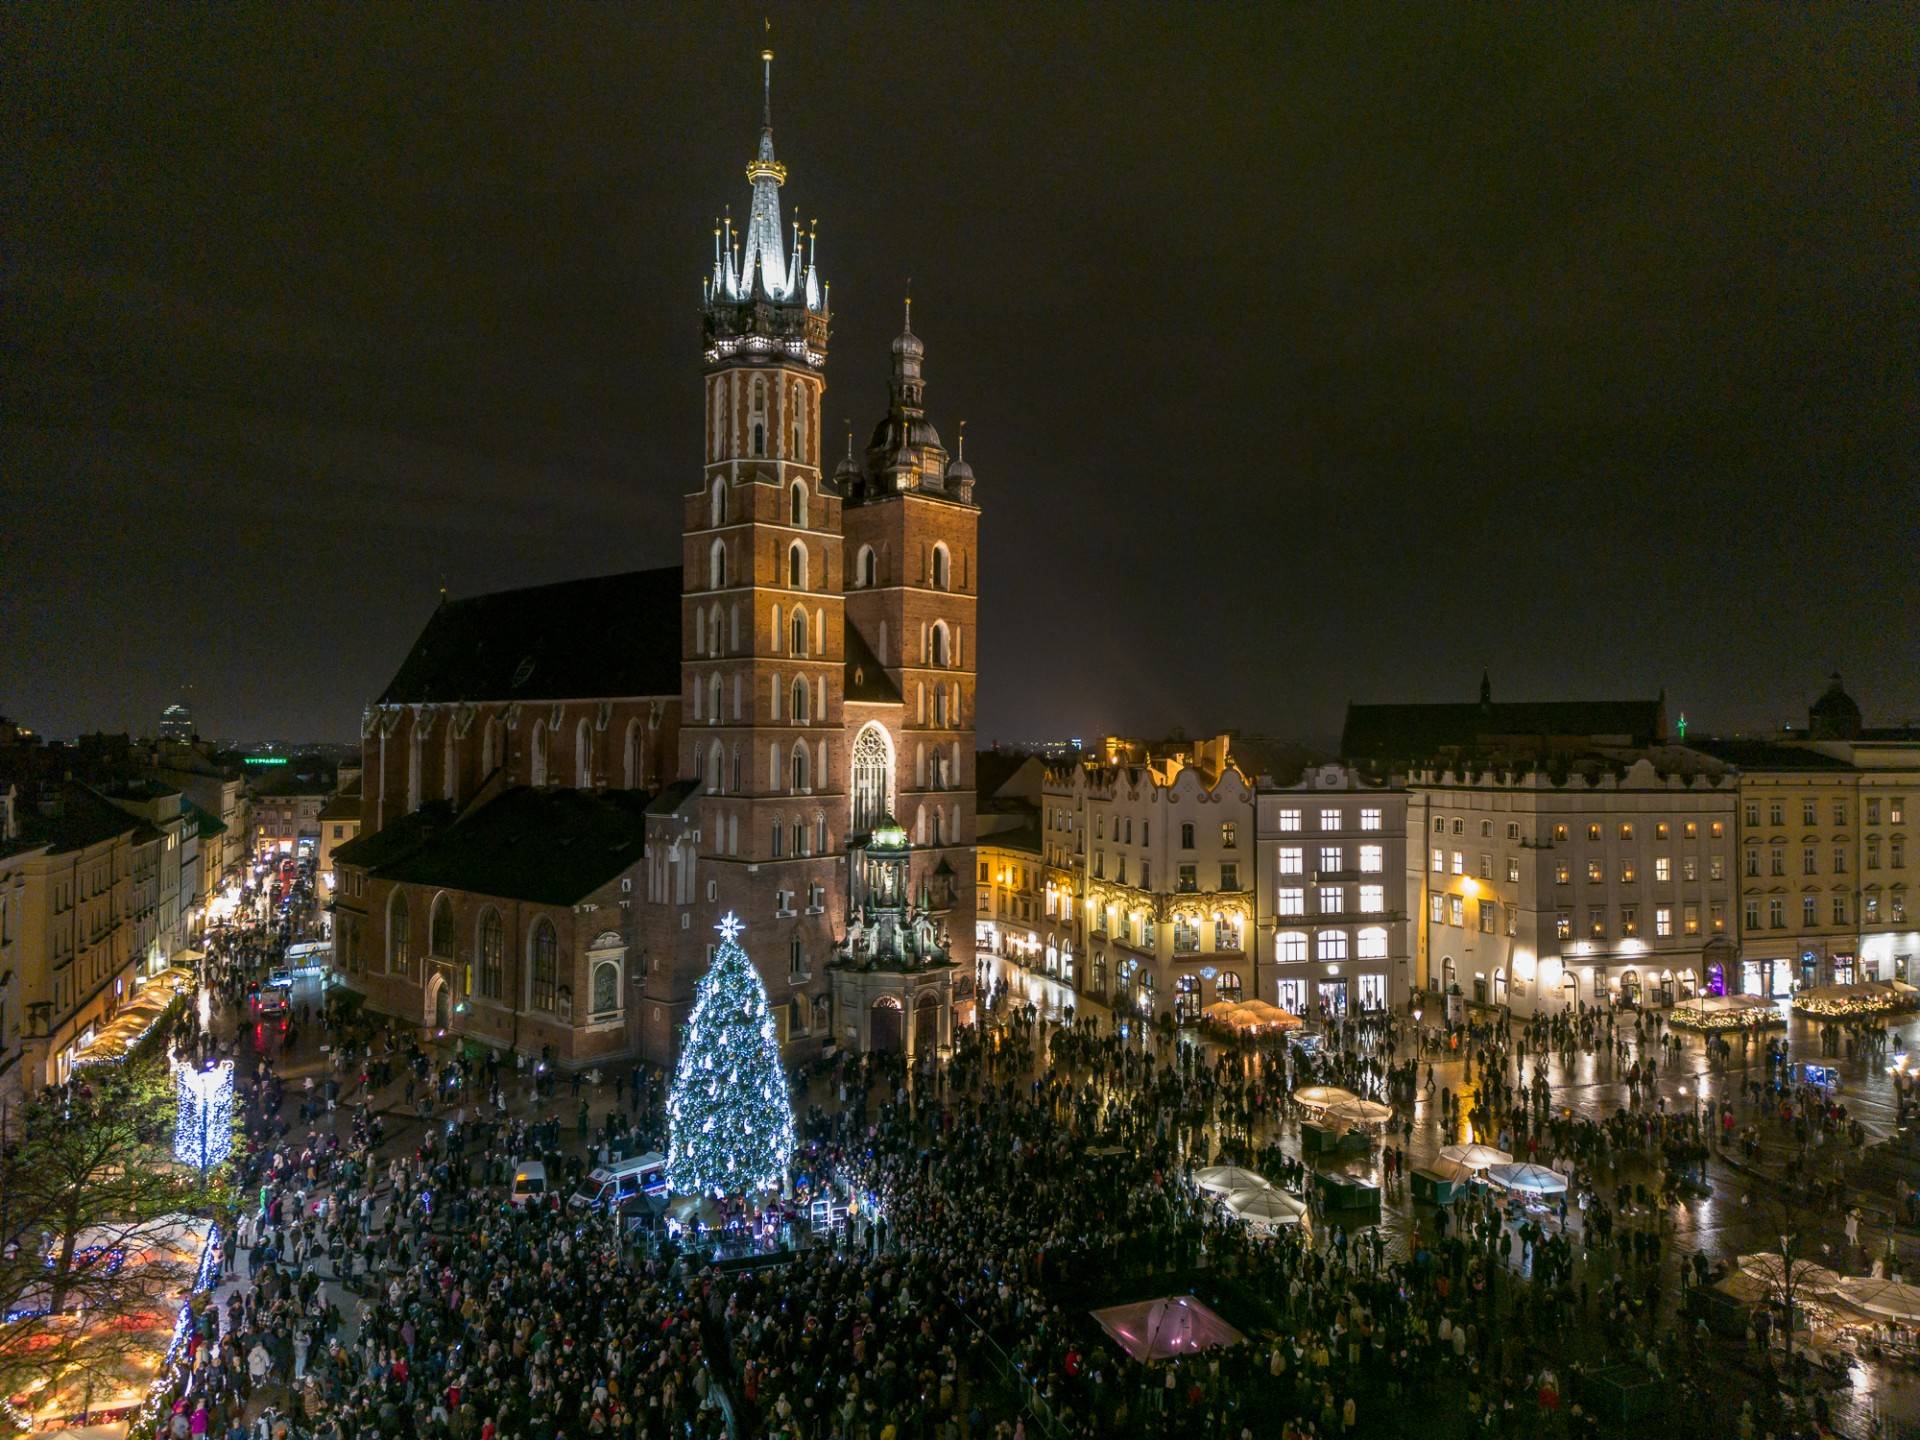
[{"left": 334, "top": 56, "right": 979, "bottom": 1064}]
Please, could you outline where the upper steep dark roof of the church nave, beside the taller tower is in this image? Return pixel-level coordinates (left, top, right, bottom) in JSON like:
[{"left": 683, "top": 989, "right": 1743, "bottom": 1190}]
[{"left": 380, "top": 564, "right": 680, "bottom": 705}]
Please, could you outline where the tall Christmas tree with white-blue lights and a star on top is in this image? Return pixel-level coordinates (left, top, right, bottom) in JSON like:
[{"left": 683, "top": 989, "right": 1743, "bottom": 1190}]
[{"left": 666, "top": 912, "right": 793, "bottom": 1196}]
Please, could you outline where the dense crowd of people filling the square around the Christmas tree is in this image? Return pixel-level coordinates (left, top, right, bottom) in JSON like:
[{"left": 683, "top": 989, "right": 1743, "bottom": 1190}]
[{"left": 127, "top": 879, "right": 1881, "bottom": 1440}]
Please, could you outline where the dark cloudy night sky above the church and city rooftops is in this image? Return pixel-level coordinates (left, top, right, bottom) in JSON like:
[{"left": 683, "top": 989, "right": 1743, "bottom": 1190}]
[{"left": 0, "top": 4, "right": 1920, "bottom": 745}]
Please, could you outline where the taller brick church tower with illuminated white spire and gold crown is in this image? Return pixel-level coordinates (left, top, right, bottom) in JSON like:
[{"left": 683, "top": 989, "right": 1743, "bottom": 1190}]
[{"left": 680, "top": 50, "right": 845, "bottom": 1033}]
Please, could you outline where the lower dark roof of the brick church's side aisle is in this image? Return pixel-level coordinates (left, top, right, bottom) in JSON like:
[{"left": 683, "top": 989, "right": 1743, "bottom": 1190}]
[{"left": 362, "top": 785, "right": 649, "bottom": 904}]
